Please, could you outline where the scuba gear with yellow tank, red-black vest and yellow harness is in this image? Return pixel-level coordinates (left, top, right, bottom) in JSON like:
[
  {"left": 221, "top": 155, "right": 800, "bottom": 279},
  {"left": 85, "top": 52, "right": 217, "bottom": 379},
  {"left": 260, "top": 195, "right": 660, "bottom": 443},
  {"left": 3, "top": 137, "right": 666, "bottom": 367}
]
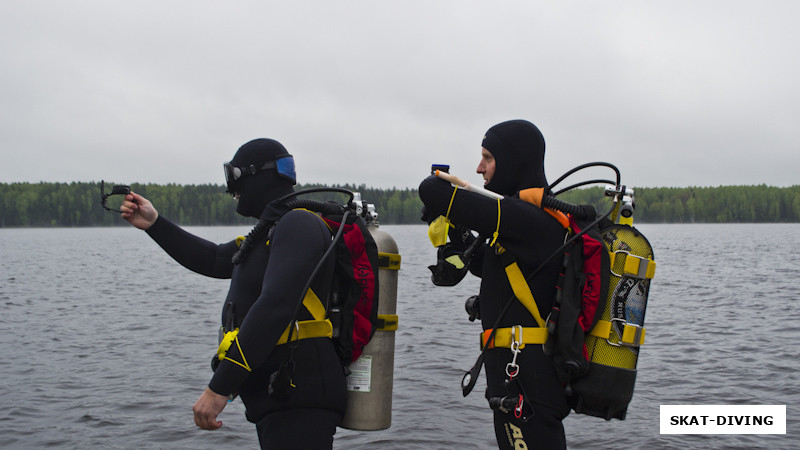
[{"left": 462, "top": 163, "right": 655, "bottom": 420}]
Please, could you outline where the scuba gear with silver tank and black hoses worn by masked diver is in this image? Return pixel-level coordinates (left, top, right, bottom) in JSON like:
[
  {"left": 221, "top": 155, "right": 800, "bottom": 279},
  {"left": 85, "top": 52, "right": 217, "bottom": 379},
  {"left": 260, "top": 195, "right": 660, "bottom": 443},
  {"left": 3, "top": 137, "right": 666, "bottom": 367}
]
[{"left": 230, "top": 188, "right": 400, "bottom": 431}]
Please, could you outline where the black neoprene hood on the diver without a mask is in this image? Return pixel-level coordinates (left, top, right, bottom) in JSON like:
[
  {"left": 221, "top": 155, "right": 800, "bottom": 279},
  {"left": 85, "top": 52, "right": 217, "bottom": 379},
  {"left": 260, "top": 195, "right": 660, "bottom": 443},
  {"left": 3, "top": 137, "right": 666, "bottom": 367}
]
[{"left": 481, "top": 120, "right": 547, "bottom": 195}]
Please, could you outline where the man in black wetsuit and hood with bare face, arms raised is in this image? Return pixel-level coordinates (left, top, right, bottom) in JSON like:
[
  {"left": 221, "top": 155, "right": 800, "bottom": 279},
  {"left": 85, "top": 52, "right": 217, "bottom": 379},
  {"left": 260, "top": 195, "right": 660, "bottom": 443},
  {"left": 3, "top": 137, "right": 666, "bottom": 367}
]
[{"left": 419, "top": 120, "right": 569, "bottom": 450}]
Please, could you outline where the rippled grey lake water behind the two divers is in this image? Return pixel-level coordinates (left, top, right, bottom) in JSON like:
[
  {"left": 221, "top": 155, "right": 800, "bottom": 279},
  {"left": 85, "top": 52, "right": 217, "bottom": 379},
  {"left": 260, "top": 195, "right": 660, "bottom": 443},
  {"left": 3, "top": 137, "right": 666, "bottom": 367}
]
[{"left": 0, "top": 224, "right": 800, "bottom": 449}]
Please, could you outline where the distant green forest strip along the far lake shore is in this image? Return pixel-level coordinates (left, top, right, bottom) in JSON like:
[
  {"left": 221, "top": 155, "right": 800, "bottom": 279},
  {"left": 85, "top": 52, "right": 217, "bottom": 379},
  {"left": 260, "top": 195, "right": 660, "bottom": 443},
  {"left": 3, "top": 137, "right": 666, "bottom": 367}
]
[{"left": 0, "top": 182, "right": 800, "bottom": 228}]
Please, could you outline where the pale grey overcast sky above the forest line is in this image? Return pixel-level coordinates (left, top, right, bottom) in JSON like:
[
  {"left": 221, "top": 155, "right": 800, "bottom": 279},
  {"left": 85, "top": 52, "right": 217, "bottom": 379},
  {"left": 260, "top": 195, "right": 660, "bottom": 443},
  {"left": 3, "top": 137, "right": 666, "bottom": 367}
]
[{"left": 0, "top": 0, "right": 800, "bottom": 188}]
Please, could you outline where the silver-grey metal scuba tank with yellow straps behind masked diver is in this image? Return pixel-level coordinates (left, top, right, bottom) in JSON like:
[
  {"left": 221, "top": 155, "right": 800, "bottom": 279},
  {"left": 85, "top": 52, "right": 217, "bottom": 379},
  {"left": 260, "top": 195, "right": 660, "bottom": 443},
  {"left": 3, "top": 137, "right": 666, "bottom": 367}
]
[{"left": 340, "top": 200, "right": 400, "bottom": 431}]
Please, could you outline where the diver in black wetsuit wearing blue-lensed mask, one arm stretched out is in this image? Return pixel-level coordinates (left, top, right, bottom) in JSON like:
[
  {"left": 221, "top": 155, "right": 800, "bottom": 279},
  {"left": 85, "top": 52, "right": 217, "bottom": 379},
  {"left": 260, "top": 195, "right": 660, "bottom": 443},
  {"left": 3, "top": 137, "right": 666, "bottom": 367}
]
[{"left": 121, "top": 139, "right": 347, "bottom": 449}]
